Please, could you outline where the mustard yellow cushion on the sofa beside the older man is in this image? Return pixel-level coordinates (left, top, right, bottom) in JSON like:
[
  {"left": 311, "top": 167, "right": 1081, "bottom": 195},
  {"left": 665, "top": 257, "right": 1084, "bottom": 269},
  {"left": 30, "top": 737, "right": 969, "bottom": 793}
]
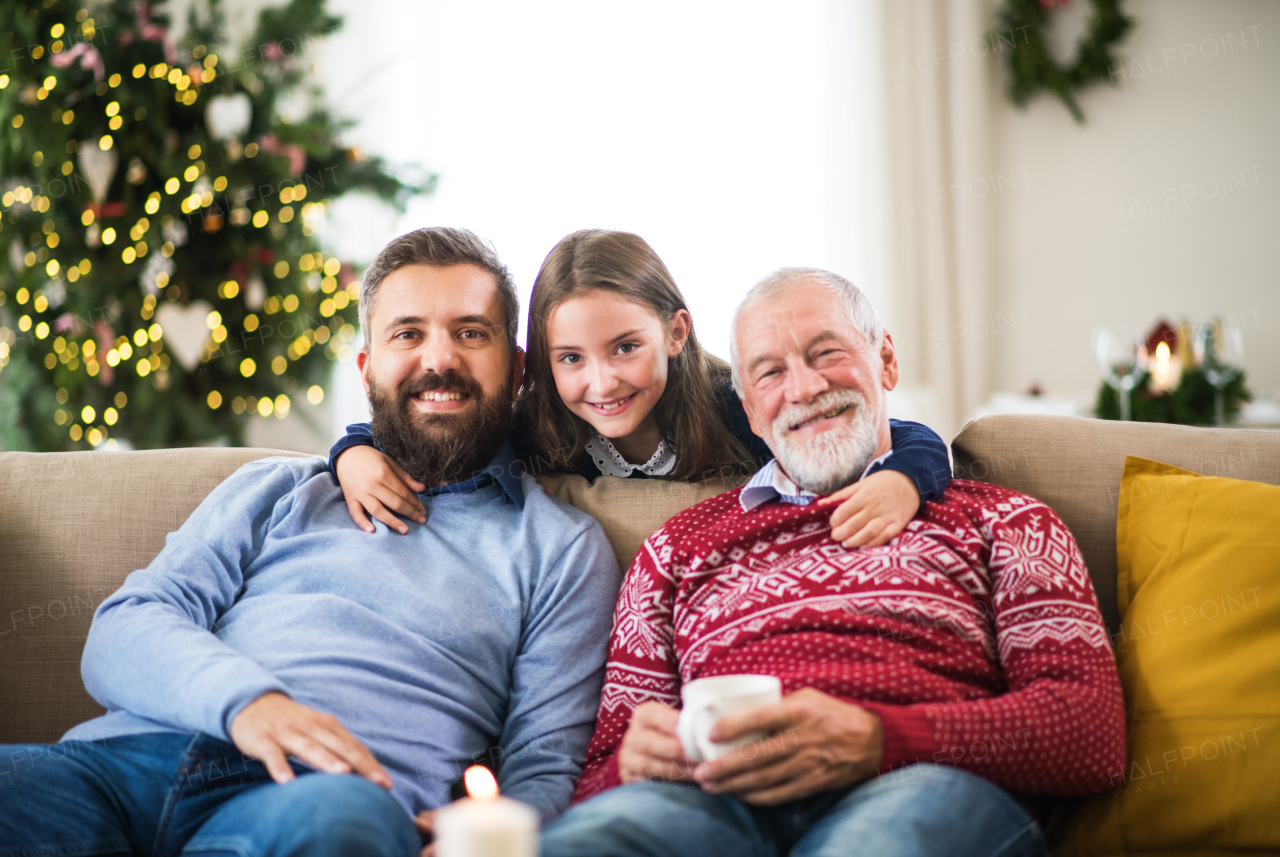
[{"left": 1055, "top": 455, "right": 1280, "bottom": 856}]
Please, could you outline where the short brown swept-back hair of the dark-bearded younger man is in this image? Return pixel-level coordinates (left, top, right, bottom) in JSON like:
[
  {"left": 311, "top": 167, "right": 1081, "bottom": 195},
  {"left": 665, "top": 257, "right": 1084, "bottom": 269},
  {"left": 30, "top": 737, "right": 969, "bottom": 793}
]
[{"left": 360, "top": 226, "right": 520, "bottom": 354}]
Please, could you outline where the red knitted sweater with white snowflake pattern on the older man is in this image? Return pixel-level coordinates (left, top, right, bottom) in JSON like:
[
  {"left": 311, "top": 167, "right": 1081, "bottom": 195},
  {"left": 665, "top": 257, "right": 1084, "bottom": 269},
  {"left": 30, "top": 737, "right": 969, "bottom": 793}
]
[{"left": 573, "top": 480, "right": 1125, "bottom": 801}]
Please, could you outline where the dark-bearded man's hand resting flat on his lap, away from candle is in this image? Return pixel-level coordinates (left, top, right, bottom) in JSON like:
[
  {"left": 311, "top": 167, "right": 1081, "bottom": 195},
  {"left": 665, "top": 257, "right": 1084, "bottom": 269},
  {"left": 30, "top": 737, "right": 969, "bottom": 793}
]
[{"left": 230, "top": 692, "right": 392, "bottom": 790}]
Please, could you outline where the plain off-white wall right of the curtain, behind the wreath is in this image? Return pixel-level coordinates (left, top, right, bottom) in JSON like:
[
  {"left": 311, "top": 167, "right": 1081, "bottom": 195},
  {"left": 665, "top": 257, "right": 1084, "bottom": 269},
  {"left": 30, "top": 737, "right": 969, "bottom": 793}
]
[{"left": 991, "top": 0, "right": 1280, "bottom": 399}]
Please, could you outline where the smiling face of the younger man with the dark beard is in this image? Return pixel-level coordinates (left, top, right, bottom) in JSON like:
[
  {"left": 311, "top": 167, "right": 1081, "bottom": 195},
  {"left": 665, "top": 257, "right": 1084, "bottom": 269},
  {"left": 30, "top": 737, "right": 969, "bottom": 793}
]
[{"left": 357, "top": 265, "right": 524, "bottom": 485}]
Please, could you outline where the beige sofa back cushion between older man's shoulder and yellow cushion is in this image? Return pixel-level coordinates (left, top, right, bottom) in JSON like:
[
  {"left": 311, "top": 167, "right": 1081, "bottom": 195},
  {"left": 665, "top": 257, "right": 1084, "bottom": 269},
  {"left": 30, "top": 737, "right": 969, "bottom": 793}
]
[{"left": 951, "top": 414, "right": 1280, "bottom": 633}]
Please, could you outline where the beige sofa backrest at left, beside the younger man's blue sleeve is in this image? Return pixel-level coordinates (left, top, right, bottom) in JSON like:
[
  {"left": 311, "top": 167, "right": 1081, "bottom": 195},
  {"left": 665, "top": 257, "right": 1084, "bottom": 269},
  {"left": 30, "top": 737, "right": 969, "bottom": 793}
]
[{"left": 0, "top": 449, "right": 307, "bottom": 743}]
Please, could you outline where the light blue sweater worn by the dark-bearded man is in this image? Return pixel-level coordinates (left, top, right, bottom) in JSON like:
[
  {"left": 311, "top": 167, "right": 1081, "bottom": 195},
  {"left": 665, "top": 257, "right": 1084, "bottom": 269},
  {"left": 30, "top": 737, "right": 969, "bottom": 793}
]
[{"left": 64, "top": 448, "right": 621, "bottom": 821}]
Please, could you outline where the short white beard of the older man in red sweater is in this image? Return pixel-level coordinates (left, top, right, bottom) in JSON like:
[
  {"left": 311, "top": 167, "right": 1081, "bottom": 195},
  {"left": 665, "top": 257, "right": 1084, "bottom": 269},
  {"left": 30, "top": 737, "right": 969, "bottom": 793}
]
[{"left": 772, "top": 389, "right": 878, "bottom": 494}]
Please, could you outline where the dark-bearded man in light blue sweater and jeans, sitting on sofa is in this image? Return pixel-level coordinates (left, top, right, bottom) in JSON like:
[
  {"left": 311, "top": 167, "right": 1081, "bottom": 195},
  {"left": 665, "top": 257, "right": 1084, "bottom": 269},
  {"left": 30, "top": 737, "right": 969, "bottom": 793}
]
[{"left": 0, "top": 229, "right": 620, "bottom": 857}]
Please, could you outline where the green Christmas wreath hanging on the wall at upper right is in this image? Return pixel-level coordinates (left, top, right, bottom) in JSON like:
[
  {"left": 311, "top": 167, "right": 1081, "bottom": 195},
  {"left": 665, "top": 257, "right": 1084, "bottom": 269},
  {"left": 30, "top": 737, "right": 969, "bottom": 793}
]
[{"left": 991, "top": 0, "right": 1133, "bottom": 123}]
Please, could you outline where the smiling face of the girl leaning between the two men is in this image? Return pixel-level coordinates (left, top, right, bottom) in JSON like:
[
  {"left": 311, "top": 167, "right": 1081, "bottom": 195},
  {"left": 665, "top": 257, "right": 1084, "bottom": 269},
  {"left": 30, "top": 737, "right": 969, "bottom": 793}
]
[{"left": 547, "top": 289, "right": 692, "bottom": 463}]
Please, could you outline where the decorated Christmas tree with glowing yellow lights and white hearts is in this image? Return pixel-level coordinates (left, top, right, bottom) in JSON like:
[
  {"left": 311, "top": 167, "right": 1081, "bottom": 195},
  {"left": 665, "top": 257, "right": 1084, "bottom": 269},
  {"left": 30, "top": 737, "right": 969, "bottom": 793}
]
[{"left": 0, "top": 0, "right": 434, "bottom": 450}]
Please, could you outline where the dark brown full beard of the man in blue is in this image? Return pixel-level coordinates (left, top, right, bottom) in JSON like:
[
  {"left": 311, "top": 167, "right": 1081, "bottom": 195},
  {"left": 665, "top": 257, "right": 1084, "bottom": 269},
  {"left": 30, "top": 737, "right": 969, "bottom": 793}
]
[{"left": 369, "top": 370, "right": 511, "bottom": 486}]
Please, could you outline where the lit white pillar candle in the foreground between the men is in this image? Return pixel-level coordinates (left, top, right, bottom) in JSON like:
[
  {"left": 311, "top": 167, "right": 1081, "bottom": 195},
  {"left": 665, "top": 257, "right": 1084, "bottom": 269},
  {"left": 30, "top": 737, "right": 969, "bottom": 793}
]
[{"left": 435, "top": 765, "right": 538, "bottom": 857}]
